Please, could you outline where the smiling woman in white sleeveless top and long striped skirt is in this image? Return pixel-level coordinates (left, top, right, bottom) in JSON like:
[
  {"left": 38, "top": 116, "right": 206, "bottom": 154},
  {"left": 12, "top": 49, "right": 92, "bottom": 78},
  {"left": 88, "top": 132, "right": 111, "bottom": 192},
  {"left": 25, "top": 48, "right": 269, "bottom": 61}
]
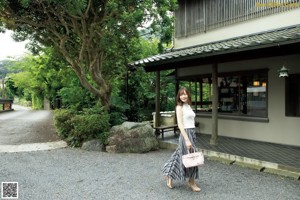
[{"left": 162, "top": 88, "right": 201, "bottom": 192}]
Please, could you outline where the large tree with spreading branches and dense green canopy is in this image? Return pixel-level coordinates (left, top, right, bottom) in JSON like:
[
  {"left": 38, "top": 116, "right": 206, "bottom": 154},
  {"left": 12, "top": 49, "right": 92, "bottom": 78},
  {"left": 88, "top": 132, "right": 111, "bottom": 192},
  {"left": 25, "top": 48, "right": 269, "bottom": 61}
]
[{"left": 0, "top": 0, "right": 177, "bottom": 107}]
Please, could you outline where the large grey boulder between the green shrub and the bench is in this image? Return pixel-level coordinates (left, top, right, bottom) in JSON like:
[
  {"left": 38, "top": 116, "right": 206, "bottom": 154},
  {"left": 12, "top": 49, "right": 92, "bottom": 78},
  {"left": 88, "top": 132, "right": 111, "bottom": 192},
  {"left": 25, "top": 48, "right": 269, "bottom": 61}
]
[{"left": 106, "top": 122, "right": 159, "bottom": 153}]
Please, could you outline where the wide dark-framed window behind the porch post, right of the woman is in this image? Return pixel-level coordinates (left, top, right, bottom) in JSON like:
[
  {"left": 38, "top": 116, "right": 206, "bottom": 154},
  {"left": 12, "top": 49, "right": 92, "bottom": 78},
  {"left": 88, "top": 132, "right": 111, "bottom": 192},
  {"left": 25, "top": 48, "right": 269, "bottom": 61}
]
[{"left": 186, "top": 70, "right": 268, "bottom": 117}]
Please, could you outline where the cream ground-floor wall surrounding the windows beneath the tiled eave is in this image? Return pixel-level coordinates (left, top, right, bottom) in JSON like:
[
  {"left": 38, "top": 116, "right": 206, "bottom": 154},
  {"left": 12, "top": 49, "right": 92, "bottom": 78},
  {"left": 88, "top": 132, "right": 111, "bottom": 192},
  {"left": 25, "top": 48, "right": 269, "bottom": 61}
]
[{"left": 178, "top": 54, "right": 300, "bottom": 146}]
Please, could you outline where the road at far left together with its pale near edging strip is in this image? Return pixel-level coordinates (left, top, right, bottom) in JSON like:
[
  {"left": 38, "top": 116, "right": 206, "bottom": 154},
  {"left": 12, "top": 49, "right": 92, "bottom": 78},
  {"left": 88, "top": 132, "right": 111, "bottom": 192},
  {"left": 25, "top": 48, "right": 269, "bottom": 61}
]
[{"left": 0, "top": 104, "right": 67, "bottom": 152}]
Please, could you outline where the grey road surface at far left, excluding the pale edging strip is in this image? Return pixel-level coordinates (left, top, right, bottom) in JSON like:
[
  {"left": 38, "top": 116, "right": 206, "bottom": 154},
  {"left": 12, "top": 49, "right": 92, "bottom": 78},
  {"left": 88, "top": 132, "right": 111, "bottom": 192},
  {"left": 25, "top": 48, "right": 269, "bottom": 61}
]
[{"left": 0, "top": 104, "right": 60, "bottom": 145}]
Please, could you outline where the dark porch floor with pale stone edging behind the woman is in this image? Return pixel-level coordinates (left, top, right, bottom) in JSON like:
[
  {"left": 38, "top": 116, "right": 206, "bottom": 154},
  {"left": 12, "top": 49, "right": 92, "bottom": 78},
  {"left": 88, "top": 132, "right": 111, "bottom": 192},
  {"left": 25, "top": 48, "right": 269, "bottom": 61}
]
[{"left": 160, "top": 132, "right": 300, "bottom": 180}]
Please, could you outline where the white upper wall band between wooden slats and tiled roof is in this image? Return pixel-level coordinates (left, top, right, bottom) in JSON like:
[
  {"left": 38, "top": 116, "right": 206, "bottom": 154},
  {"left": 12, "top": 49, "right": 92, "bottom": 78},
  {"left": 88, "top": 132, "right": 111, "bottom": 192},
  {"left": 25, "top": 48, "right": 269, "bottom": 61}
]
[{"left": 174, "top": 8, "right": 300, "bottom": 49}]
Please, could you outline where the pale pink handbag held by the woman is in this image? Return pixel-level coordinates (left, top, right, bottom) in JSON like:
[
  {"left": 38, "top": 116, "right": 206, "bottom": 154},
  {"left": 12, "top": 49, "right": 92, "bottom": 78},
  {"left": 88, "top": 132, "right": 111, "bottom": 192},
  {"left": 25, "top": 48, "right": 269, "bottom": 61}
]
[{"left": 182, "top": 149, "right": 204, "bottom": 168}]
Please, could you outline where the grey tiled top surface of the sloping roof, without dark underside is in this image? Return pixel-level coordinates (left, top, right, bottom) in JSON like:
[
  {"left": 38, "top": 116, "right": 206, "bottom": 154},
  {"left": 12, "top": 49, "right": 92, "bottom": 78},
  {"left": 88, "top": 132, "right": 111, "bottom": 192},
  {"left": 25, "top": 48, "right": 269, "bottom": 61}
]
[{"left": 129, "top": 25, "right": 300, "bottom": 67}]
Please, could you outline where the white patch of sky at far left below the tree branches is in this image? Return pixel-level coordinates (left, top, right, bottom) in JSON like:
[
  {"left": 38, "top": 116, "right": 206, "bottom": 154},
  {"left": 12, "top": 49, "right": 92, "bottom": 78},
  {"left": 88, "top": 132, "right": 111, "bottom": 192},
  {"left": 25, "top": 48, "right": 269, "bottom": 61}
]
[{"left": 0, "top": 31, "right": 28, "bottom": 60}]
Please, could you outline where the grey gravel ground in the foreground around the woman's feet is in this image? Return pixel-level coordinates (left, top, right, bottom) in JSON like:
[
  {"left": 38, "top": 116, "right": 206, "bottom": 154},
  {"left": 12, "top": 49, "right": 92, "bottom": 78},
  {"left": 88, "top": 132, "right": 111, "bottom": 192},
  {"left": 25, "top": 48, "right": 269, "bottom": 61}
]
[{"left": 0, "top": 148, "right": 300, "bottom": 200}]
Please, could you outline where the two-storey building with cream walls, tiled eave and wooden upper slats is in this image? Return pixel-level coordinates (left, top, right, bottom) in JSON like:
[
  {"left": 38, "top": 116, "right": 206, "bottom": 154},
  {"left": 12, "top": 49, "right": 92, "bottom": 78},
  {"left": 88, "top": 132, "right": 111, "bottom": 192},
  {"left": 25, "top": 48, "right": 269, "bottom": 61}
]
[{"left": 130, "top": 0, "right": 300, "bottom": 146}]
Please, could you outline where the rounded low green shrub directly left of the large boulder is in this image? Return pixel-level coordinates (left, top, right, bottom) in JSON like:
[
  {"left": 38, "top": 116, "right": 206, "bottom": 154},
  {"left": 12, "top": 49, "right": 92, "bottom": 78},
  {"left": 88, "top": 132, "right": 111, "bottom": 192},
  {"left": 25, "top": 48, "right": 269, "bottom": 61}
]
[{"left": 54, "top": 106, "right": 110, "bottom": 147}]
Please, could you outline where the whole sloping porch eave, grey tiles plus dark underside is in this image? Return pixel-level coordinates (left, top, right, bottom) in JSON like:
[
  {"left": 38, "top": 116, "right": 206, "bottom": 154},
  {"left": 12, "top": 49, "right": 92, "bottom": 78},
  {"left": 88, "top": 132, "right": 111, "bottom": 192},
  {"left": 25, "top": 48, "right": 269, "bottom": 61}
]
[{"left": 129, "top": 24, "right": 300, "bottom": 72}]
